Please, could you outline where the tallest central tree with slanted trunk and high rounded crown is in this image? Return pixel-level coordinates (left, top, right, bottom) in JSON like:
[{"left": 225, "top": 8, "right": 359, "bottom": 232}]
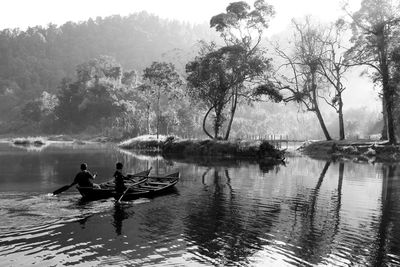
[{"left": 210, "top": 0, "right": 275, "bottom": 140}]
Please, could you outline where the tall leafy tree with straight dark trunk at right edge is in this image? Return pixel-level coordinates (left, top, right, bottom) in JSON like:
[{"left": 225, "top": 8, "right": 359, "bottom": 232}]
[{"left": 347, "top": 0, "right": 400, "bottom": 144}]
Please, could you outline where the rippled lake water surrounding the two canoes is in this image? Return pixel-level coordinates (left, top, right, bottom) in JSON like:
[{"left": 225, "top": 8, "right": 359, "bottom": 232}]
[{"left": 0, "top": 143, "right": 400, "bottom": 266}]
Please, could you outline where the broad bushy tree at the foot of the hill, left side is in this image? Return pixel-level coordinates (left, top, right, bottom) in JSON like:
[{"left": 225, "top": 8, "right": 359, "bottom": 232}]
[{"left": 55, "top": 57, "right": 128, "bottom": 130}]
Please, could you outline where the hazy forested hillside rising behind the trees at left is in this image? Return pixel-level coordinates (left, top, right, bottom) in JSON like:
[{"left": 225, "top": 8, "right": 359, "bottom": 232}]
[{"left": 0, "top": 12, "right": 215, "bottom": 108}]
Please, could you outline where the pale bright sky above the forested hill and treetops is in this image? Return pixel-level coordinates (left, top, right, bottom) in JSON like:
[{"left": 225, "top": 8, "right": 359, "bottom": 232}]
[{"left": 0, "top": 0, "right": 380, "bottom": 109}]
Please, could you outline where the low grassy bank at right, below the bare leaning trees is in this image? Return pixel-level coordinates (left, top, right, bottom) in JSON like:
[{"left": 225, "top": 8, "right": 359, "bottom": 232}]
[{"left": 299, "top": 140, "right": 400, "bottom": 162}]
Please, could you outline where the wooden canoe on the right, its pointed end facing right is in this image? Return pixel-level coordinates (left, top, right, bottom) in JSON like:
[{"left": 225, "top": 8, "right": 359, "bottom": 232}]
[{"left": 114, "top": 172, "right": 180, "bottom": 200}]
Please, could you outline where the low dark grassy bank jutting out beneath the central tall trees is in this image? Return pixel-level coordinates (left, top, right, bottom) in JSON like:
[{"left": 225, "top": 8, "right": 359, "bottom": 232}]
[{"left": 119, "top": 136, "right": 284, "bottom": 160}]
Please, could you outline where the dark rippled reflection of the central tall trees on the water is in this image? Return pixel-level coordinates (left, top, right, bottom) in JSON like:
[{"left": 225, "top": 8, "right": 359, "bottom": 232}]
[{"left": 185, "top": 168, "right": 280, "bottom": 264}]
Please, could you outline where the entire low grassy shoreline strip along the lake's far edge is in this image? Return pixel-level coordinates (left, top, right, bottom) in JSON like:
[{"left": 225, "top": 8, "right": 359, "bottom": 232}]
[{"left": 6, "top": 134, "right": 400, "bottom": 164}]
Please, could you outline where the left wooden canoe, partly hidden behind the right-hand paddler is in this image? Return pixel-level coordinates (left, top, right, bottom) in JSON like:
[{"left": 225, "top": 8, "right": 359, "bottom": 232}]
[{"left": 76, "top": 168, "right": 151, "bottom": 200}]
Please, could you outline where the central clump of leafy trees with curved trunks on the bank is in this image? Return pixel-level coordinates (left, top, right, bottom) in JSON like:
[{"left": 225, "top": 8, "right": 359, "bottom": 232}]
[{"left": 186, "top": 0, "right": 279, "bottom": 140}]
